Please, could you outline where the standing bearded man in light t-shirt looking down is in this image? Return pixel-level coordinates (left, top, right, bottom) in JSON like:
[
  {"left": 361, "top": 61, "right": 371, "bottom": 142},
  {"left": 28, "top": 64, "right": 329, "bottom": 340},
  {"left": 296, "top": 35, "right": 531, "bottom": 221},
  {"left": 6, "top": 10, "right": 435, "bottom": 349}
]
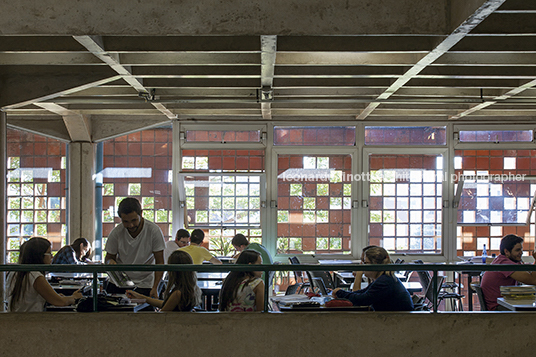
[{"left": 104, "top": 197, "right": 166, "bottom": 298}]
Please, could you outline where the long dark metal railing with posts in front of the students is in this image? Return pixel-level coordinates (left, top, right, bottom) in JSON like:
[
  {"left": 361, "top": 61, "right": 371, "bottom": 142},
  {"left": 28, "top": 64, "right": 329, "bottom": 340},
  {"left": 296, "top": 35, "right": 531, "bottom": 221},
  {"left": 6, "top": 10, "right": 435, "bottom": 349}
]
[{"left": 0, "top": 264, "right": 536, "bottom": 312}]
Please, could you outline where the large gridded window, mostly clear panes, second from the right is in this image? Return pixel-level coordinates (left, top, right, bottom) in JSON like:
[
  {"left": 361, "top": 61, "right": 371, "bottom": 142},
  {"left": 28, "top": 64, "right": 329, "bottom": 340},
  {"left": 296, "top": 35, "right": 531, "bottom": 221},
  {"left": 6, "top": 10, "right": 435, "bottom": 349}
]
[{"left": 367, "top": 154, "right": 443, "bottom": 254}]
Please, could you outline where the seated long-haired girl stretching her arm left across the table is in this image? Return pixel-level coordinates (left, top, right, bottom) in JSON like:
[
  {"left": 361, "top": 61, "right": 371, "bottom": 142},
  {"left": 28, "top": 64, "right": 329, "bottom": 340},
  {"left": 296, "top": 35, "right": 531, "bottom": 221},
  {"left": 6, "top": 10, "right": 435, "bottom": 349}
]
[{"left": 126, "top": 250, "right": 201, "bottom": 311}]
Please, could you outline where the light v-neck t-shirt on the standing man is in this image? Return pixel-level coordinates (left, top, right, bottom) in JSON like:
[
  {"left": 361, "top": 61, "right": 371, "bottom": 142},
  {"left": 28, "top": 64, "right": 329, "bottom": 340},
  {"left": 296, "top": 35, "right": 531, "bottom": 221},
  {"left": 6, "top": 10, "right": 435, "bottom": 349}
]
[{"left": 105, "top": 220, "right": 166, "bottom": 288}]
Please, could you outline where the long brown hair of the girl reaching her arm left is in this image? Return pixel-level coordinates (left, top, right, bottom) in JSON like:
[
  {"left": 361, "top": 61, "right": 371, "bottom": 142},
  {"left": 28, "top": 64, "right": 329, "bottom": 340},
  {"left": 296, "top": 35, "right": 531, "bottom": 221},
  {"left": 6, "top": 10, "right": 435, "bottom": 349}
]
[{"left": 164, "top": 250, "right": 201, "bottom": 311}]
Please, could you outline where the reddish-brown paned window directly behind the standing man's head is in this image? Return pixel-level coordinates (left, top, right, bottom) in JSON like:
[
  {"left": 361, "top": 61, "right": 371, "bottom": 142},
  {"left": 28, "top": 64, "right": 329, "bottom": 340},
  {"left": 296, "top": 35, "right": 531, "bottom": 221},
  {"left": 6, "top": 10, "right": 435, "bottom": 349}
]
[{"left": 102, "top": 128, "right": 174, "bottom": 247}]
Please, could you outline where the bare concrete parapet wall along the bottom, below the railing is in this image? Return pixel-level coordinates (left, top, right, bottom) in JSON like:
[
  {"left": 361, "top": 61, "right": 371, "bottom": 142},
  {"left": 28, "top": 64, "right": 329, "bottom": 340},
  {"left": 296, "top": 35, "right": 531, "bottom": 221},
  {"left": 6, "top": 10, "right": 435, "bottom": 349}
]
[{"left": 0, "top": 312, "right": 536, "bottom": 357}]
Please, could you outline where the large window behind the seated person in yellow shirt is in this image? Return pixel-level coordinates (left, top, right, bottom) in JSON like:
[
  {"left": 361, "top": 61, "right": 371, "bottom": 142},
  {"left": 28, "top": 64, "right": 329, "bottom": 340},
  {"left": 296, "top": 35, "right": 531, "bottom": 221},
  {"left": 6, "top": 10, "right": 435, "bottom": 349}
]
[{"left": 178, "top": 146, "right": 265, "bottom": 255}]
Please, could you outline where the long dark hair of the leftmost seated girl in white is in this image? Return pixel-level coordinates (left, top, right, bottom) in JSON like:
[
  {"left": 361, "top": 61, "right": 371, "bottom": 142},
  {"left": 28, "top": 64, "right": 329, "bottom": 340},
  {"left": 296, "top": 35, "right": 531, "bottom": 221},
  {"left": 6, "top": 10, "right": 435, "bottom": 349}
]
[{"left": 9, "top": 237, "right": 52, "bottom": 310}]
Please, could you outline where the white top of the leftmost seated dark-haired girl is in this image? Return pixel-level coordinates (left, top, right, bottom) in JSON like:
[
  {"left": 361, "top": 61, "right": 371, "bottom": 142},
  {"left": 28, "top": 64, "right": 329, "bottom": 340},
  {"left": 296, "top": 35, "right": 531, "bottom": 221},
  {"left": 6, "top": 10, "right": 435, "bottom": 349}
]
[{"left": 7, "top": 271, "right": 46, "bottom": 312}]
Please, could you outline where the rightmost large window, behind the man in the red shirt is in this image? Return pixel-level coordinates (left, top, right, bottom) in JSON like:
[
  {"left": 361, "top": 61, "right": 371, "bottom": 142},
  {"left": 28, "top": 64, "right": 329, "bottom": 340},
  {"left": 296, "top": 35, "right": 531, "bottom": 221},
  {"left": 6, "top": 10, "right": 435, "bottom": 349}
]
[{"left": 454, "top": 147, "right": 536, "bottom": 256}]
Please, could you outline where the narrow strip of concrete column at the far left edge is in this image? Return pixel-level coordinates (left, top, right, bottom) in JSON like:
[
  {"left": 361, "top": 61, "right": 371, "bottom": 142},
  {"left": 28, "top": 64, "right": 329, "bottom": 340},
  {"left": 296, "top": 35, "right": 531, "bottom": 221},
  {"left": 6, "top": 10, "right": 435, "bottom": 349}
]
[{"left": 0, "top": 111, "right": 7, "bottom": 311}]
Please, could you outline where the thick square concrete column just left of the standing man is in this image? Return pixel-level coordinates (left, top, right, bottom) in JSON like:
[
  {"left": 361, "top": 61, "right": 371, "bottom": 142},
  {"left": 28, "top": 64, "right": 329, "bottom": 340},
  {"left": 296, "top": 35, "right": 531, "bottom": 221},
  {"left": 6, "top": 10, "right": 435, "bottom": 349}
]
[{"left": 67, "top": 142, "right": 96, "bottom": 246}]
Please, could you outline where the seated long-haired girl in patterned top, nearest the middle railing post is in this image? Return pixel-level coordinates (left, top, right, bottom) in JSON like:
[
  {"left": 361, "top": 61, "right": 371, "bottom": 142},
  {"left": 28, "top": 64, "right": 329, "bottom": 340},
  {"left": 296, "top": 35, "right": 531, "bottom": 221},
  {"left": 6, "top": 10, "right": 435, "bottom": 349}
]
[{"left": 220, "top": 249, "right": 264, "bottom": 312}]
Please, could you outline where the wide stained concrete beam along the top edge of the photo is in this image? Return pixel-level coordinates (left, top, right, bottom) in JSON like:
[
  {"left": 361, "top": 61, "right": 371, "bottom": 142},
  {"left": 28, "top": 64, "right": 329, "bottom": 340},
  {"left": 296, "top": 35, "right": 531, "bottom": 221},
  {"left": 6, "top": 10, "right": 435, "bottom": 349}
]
[{"left": 0, "top": 0, "right": 450, "bottom": 36}]
